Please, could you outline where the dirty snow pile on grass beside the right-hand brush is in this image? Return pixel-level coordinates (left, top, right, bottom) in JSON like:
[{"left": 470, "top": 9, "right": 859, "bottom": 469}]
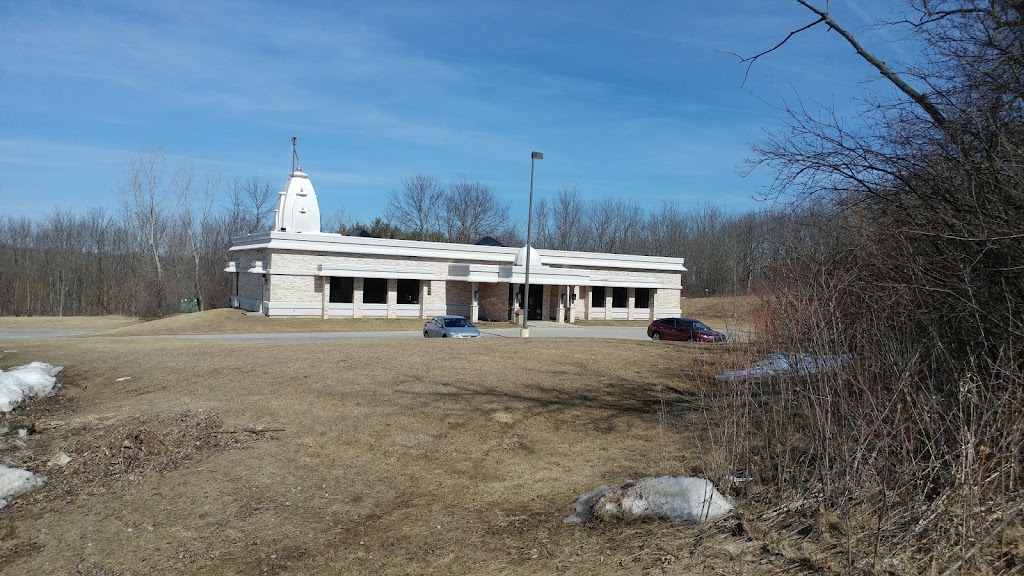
[{"left": 562, "top": 476, "right": 733, "bottom": 524}]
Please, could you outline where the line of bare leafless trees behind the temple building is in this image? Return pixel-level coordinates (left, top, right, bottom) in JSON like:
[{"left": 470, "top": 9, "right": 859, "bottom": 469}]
[{"left": 0, "top": 151, "right": 788, "bottom": 318}]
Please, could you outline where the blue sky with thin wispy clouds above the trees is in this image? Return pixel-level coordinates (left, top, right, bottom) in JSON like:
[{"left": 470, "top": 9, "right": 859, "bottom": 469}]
[{"left": 0, "top": 0, "right": 913, "bottom": 220}]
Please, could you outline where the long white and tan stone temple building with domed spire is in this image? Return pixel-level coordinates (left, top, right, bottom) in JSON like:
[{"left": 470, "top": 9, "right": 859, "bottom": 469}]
[{"left": 225, "top": 156, "right": 686, "bottom": 322}]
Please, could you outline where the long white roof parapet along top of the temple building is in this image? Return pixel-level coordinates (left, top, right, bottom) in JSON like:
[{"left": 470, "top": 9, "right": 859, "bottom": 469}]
[{"left": 230, "top": 232, "right": 686, "bottom": 276}]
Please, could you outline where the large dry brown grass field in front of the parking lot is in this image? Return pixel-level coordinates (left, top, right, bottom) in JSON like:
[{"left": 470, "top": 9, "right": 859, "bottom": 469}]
[{"left": 0, "top": 297, "right": 815, "bottom": 575}]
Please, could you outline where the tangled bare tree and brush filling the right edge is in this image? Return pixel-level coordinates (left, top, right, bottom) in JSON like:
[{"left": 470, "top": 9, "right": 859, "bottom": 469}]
[{"left": 716, "top": 0, "right": 1024, "bottom": 574}]
